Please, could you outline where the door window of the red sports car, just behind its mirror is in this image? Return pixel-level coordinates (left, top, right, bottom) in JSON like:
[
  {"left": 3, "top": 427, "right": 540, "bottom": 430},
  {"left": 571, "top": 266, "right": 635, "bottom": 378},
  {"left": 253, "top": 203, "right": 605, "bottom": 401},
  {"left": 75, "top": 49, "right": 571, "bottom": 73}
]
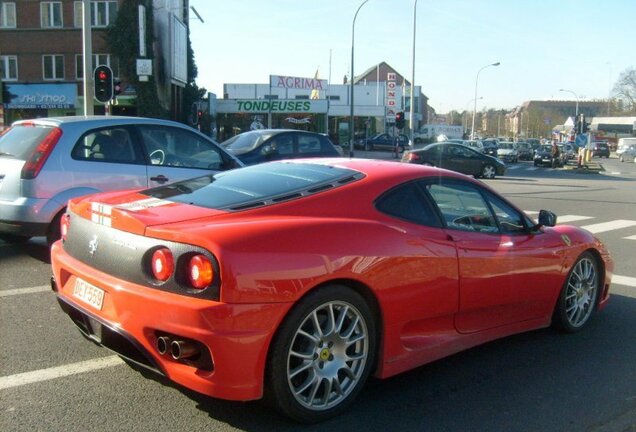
[{"left": 427, "top": 183, "right": 499, "bottom": 233}]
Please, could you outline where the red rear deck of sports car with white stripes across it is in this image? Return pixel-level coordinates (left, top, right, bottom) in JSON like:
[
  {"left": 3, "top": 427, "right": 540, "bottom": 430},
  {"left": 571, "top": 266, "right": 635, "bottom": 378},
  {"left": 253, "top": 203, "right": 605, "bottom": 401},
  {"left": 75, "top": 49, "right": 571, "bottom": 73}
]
[{"left": 68, "top": 191, "right": 228, "bottom": 235}]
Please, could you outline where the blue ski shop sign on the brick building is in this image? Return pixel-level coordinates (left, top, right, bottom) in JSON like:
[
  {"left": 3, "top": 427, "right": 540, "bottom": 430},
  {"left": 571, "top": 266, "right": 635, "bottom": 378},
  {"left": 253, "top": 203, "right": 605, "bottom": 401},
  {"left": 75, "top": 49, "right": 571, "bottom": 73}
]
[{"left": 4, "top": 84, "right": 77, "bottom": 109}]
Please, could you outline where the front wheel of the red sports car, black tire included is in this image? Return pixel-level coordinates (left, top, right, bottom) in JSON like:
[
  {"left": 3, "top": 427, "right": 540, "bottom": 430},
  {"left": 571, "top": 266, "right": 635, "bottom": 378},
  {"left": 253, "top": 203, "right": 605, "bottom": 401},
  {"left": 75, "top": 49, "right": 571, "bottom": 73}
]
[{"left": 552, "top": 252, "right": 600, "bottom": 333}]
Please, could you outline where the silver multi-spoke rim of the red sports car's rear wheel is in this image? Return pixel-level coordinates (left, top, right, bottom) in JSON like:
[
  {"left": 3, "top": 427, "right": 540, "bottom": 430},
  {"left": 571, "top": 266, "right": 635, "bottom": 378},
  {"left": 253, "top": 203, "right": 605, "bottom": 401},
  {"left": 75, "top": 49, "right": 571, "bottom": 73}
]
[{"left": 287, "top": 301, "right": 369, "bottom": 410}]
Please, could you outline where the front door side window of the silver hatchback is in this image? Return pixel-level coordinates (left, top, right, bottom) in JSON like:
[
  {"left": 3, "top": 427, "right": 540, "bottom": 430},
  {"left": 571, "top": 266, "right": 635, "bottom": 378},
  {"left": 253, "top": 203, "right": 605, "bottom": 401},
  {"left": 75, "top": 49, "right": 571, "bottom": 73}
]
[{"left": 139, "top": 125, "right": 225, "bottom": 171}]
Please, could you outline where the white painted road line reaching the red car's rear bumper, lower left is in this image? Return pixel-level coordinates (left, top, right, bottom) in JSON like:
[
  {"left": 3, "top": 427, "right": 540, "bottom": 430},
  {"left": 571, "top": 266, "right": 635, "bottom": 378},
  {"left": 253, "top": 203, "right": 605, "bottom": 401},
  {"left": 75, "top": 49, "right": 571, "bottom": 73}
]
[{"left": 0, "top": 356, "right": 124, "bottom": 390}]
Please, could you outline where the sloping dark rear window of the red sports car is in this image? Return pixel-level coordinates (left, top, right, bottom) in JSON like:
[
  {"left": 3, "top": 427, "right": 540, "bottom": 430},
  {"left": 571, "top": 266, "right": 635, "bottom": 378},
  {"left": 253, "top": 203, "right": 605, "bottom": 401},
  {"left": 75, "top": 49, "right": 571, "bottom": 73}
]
[{"left": 144, "top": 162, "right": 363, "bottom": 211}]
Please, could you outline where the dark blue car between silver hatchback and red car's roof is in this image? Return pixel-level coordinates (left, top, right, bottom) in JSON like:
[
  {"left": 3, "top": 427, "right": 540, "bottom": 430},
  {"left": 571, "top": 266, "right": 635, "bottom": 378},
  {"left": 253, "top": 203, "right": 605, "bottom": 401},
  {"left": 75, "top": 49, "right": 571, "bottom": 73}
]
[{"left": 221, "top": 129, "right": 342, "bottom": 165}]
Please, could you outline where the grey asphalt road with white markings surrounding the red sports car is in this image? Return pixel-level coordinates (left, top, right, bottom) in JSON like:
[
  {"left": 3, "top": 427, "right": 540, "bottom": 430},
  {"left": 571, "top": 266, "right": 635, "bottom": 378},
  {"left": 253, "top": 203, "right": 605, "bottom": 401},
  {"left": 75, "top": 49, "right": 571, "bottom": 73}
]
[{"left": 0, "top": 152, "right": 636, "bottom": 432}]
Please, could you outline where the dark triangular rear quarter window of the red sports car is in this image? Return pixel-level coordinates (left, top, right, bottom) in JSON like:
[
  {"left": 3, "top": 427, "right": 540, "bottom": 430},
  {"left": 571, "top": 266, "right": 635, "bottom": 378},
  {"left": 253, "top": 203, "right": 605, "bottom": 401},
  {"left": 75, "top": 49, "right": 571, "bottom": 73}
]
[{"left": 376, "top": 182, "right": 440, "bottom": 227}]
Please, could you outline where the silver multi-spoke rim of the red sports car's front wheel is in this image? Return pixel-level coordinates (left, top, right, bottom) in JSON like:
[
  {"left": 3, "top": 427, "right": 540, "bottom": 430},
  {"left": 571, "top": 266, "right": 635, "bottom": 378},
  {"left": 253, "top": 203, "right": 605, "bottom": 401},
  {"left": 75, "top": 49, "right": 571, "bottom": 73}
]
[{"left": 565, "top": 258, "right": 598, "bottom": 327}]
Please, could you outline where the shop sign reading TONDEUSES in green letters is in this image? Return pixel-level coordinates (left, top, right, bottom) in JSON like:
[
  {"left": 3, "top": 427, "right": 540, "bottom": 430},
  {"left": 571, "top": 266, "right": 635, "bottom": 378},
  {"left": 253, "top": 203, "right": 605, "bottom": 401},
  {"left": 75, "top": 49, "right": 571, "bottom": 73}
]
[{"left": 217, "top": 99, "right": 329, "bottom": 114}]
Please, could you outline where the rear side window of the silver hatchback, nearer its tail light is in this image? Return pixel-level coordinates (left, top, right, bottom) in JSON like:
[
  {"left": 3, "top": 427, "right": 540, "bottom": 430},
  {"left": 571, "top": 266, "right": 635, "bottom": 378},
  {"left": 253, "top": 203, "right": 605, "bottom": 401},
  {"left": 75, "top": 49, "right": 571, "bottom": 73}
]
[{"left": 71, "top": 127, "right": 143, "bottom": 164}]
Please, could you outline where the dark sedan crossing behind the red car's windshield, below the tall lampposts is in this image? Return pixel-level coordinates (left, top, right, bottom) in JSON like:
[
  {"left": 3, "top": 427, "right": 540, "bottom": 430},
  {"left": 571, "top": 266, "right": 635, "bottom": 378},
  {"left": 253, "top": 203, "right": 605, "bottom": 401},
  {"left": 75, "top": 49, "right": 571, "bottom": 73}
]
[{"left": 402, "top": 143, "right": 506, "bottom": 179}]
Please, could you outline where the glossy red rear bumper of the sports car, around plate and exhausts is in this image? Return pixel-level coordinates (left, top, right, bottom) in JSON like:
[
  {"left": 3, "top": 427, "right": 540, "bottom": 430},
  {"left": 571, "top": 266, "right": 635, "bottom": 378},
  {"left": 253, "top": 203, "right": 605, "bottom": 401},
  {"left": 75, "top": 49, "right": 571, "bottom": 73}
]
[{"left": 51, "top": 241, "right": 290, "bottom": 400}]
